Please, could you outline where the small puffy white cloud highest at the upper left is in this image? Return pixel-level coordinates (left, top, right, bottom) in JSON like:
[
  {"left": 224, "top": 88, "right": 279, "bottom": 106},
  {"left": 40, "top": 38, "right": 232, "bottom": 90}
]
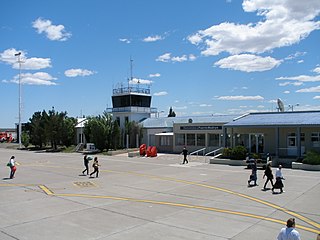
[{"left": 32, "top": 18, "right": 71, "bottom": 41}]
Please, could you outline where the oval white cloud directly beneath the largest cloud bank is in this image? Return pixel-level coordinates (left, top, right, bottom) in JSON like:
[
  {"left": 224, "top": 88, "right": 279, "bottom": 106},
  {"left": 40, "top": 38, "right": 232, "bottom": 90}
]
[{"left": 214, "top": 54, "right": 281, "bottom": 72}]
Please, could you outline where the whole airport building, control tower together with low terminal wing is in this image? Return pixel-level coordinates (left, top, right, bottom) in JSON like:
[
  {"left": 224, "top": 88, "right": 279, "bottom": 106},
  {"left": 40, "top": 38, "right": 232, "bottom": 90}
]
[{"left": 77, "top": 75, "right": 320, "bottom": 158}]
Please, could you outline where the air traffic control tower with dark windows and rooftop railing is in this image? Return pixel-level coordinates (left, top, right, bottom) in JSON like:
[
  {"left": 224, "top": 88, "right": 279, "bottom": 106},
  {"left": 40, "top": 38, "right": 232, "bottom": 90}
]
[{"left": 107, "top": 82, "right": 157, "bottom": 129}]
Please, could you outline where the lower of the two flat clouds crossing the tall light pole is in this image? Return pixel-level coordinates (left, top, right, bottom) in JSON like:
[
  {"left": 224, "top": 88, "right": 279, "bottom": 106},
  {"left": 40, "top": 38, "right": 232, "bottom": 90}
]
[{"left": 3, "top": 72, "right": 57, "bottom": 86}]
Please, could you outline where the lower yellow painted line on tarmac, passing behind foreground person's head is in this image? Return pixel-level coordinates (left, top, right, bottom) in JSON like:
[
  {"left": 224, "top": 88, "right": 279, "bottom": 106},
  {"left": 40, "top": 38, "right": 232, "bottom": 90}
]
[{"left": 53, "top": 193, "right": 320, "bottom": 234}]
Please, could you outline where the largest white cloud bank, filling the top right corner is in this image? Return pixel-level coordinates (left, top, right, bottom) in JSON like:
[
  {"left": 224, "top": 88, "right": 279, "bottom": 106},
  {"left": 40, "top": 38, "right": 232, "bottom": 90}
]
[{"left": 188, "top": 0, "right": 320, "bottom": 56}]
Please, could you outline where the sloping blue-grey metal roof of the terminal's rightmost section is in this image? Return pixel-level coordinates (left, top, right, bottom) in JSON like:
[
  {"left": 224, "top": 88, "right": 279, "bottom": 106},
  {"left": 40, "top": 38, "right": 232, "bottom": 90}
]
[{"left": 224, "top": 111, "right": 320, "bottom": 127}]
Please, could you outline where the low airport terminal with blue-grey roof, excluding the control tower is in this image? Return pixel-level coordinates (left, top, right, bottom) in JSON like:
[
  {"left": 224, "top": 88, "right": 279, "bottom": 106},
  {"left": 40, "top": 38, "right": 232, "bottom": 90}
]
[{"left": 142, "top": 111, "right": 320, "bottom": 157}]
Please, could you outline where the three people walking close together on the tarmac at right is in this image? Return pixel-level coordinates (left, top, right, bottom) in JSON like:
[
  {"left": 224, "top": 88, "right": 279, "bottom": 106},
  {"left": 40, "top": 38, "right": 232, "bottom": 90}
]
[{"left": 248, "top": 160, "right": 284, "bottom": 193}]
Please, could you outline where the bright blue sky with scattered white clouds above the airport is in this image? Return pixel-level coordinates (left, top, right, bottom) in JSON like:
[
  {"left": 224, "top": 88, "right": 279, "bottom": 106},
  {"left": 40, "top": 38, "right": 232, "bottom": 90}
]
[{"left": 0, "top": 0, "right": 320, "bottom": 128}]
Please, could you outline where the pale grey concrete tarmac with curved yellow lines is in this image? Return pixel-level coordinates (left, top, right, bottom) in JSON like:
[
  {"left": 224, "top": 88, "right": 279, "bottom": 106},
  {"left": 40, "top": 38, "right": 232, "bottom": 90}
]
[{"left": 0, "top": 148, "right": 320, "bottom": 240}]
